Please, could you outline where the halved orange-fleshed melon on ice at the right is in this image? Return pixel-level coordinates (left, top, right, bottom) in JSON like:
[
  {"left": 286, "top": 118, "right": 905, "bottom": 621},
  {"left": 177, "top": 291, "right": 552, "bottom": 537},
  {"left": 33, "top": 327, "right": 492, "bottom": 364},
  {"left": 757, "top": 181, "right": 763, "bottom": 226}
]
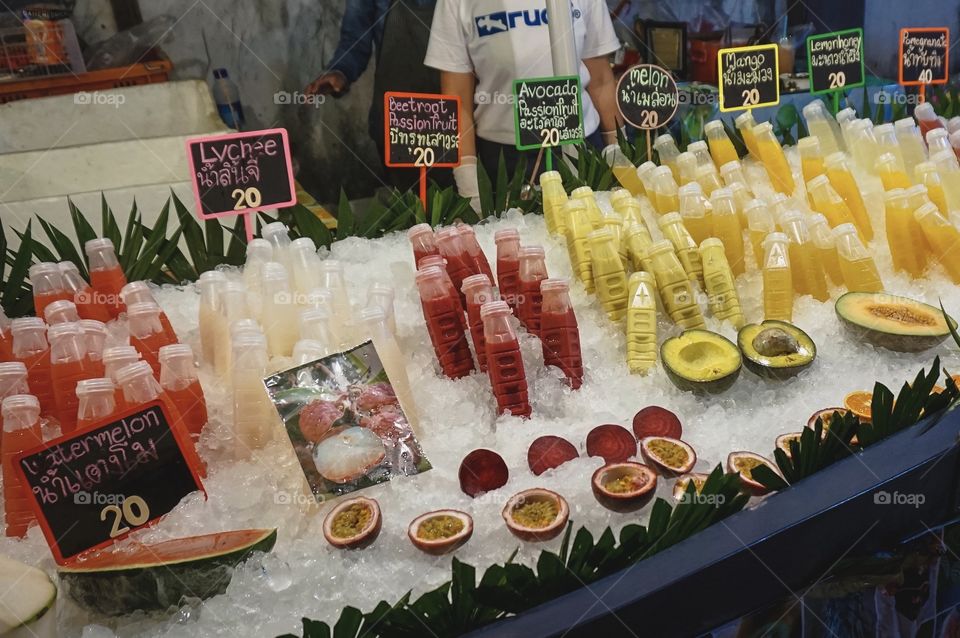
[{"left": 836, "top": 292, "right": 957, "bottom": 352}]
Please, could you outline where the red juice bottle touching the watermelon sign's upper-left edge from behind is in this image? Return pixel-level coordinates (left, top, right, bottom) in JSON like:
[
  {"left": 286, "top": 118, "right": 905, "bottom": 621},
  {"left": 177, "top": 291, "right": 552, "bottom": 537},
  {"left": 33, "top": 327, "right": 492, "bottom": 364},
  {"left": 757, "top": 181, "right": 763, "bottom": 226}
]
[{"left": 47, "top": 323, "right": 96, "bottom": 434}]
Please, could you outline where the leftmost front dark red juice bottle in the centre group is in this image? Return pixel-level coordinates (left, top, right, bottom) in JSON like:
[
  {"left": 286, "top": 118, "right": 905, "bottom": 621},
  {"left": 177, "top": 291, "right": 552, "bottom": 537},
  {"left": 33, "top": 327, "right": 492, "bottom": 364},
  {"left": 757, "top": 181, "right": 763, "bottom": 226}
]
[{"left": 416, "top": 266, "right": 474, "bottom": 379}]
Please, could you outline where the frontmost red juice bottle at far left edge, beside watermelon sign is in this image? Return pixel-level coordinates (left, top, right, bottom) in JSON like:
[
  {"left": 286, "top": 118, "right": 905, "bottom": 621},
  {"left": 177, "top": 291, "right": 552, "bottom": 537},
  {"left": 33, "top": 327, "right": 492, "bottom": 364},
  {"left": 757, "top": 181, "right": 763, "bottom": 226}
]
[{"left": 0, "top": 394, "right": 43, "bottom": 538}]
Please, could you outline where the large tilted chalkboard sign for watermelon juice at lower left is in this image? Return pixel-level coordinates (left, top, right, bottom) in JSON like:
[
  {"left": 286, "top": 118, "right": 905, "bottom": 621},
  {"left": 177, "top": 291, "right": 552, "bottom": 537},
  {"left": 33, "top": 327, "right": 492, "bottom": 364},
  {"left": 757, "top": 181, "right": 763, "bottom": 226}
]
[{"left": 15, "top": 402, "right": 203, "bottom": 564}]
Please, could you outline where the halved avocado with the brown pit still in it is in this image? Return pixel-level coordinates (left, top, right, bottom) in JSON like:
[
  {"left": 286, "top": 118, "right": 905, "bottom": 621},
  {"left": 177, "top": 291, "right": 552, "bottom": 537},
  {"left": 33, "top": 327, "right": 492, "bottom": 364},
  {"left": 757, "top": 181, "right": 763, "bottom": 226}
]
[{"left": 737, "top": 320, "right": 817, "bottom": 379}]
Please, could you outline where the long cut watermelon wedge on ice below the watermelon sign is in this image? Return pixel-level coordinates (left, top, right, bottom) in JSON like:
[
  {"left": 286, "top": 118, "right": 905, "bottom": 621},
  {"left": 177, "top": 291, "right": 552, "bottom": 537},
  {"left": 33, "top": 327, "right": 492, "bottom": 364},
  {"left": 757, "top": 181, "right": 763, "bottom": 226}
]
[{"left": 58, "top": 529, "right": 277, "bottom": 616}]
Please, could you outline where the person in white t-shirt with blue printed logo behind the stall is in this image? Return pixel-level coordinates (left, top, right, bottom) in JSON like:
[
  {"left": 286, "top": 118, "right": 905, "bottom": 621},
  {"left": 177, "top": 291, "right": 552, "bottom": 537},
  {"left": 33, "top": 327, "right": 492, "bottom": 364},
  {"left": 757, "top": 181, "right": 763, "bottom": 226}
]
[{"left": 424, "top": 0, "right": 620, "bottom": 202}]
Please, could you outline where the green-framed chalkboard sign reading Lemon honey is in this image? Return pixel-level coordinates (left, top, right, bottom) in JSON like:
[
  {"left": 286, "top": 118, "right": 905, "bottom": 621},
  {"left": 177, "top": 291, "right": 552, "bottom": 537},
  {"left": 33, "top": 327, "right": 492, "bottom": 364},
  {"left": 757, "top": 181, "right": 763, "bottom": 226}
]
[{"left": 807, "top": 29, "right": 866, "bottom": 95}]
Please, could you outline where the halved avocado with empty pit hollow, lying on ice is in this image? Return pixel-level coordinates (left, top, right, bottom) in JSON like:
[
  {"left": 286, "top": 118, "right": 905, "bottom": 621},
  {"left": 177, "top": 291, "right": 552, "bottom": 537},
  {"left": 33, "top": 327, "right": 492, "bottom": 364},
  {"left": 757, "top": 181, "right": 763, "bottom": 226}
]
[{"left": 660, "top": 330, "right": 743, "bottom": 394}]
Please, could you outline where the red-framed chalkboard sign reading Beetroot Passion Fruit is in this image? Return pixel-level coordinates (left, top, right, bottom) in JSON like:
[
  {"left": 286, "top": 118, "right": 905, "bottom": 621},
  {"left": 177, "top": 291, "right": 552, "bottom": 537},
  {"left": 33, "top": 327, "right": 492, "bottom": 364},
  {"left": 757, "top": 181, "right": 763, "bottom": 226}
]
[{"left": 383, "top": 92, "right": 460, "bottom": 168}]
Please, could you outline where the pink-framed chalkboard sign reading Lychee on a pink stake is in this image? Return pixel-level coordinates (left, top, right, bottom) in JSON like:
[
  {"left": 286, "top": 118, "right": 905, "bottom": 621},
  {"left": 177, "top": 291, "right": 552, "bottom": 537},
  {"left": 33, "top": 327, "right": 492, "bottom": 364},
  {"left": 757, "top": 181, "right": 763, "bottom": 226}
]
[{"left": 187, "top": 128, "right": 297, "bottom": 241}]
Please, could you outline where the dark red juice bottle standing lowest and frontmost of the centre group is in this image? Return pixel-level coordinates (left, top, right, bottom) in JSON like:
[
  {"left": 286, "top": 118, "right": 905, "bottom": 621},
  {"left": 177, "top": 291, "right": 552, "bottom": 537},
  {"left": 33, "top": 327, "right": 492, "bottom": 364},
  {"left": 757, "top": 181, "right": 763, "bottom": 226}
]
[{"left": 480, "top": 301, "right": 532, "bottom": 418}]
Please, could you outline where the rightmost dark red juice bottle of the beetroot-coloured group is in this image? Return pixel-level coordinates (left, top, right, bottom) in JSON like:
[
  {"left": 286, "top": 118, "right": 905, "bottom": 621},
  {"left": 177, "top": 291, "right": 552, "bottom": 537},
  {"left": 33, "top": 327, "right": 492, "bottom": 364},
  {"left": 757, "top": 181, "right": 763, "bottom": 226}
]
[{"left": 540, "top": 279, "right": 583, "bottom": 390}]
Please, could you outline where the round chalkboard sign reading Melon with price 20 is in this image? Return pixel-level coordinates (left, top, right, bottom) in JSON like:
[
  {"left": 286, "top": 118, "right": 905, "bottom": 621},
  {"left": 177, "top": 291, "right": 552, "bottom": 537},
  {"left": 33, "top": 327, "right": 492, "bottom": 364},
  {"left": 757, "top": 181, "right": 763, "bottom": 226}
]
[{"left": 617, "top": 64, "right": 680, "bottom": 130}]
